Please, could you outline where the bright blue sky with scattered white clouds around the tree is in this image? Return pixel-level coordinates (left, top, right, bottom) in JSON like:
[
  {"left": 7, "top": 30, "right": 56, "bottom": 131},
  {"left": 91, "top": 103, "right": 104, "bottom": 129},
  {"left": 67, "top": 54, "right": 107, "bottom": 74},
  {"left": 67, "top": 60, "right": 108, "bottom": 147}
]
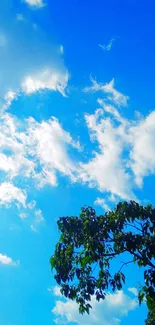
[{"left": 0, "top": 0, "right": 155, "bottom": 325}]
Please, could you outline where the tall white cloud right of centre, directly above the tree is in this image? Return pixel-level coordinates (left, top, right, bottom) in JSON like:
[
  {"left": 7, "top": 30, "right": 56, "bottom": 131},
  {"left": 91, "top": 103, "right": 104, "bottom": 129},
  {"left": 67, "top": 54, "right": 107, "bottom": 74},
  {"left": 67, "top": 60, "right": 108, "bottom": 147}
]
[{"left": 80, "top": 109, "right": 134, "bottom": 199}]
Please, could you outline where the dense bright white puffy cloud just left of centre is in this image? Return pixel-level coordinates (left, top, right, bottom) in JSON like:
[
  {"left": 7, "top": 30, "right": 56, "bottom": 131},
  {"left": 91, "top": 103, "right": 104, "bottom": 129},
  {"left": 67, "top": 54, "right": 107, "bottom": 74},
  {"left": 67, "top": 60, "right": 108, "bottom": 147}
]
[{"left": 27, "top": 118, "right": 79, "bottom": 186}]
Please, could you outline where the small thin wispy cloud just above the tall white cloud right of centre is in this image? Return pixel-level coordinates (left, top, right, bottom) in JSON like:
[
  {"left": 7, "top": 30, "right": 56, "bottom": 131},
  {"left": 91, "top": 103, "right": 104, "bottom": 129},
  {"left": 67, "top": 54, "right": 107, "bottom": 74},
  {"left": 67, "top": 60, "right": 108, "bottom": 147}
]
[{"left": 84, "top": 77, "right": 129, "bottom": 106}]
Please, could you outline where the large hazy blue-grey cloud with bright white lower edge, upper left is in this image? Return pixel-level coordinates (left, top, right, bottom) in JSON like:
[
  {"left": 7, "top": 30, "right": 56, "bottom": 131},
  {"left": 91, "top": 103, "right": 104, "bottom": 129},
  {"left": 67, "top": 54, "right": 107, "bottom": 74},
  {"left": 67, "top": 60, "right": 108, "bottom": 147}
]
[{"left": 0, "top": 6, "right": 68, "bottom": 104}]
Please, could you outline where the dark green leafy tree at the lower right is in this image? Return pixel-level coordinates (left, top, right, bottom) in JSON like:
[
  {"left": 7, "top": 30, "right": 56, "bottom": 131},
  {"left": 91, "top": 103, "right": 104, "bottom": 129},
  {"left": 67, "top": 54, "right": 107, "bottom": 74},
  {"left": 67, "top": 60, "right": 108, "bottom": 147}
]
[{"left": 50, "top": 201, "right": 155, "bottom": 325}]
